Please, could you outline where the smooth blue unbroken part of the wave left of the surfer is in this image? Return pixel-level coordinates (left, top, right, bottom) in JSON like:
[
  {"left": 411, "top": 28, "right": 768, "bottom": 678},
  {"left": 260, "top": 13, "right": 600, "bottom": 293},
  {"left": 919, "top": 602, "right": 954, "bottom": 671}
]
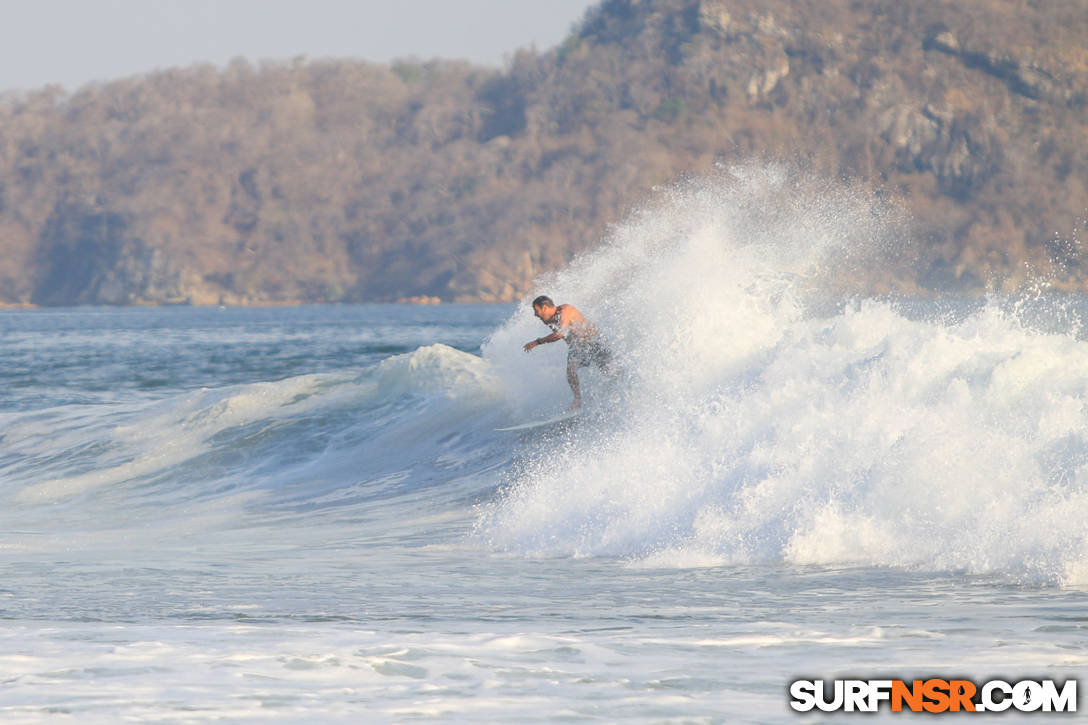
[{"left": 0, "top": 344, "right": 509, "bottom": 545}]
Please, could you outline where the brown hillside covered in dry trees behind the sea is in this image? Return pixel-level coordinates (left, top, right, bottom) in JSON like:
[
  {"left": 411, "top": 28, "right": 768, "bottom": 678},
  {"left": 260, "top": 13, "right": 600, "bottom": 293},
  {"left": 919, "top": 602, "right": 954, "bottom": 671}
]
[{"left": 0, "top": 0, "right": 1088, "bottom": 305}]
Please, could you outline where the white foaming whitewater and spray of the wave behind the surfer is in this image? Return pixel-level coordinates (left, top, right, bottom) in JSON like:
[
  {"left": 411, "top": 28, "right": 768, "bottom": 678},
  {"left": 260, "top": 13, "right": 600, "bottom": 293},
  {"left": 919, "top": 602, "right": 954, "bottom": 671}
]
[{"left": 475, "top": 167, "right": 1088, "bottom": 585}]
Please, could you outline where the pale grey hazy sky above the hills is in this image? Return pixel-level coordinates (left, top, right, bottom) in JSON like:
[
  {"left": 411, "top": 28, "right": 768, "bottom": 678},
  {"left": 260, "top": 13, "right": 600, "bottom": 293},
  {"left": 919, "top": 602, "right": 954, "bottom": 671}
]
[{"left": 0, "top": 0, "right": 596, "bottom": 90}]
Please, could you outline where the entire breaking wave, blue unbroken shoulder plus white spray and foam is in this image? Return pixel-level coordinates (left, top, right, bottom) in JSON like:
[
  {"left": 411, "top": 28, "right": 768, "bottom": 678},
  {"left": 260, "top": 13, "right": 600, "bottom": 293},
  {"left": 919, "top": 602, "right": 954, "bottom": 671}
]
[{"left": 8, "top": 165, "right": 1088, "bottom": 586}]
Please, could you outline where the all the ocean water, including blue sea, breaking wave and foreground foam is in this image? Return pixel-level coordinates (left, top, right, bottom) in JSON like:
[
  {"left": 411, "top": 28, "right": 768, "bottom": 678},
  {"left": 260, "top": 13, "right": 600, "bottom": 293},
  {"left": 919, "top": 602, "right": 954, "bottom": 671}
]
[{"left": 0, "top": 167, "right": 1088, "bottom": 723}]
